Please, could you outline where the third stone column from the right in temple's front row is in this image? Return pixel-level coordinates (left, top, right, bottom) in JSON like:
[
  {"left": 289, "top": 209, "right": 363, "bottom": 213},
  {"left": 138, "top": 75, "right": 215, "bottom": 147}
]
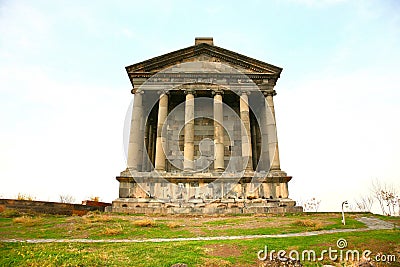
[{"left": 213, "top": 90, "right": 225, "bottom": 172}]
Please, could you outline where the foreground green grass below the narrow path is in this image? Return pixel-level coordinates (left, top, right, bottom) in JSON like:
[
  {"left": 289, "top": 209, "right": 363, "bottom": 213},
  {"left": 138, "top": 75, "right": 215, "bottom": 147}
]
[{"left": 0, "top": 230, "right": 400, "bottom": 266}]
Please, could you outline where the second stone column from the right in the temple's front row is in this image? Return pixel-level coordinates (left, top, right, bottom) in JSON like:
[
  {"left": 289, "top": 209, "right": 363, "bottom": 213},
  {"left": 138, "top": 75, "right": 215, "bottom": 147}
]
[{"left": 240, "top": 91, "right": 253, "bottom": 171}]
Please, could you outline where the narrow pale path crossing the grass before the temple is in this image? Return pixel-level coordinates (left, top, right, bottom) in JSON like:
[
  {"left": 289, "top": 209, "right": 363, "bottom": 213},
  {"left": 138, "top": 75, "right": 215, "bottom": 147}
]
[{"left": 0, "top": 217, "right": 395, "bottom": 243}]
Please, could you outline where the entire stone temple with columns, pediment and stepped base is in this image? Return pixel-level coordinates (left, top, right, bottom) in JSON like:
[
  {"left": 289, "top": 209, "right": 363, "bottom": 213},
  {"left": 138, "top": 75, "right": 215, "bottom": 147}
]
[{"left": 112, "top": 38, "right": 302, "bottom": 214}]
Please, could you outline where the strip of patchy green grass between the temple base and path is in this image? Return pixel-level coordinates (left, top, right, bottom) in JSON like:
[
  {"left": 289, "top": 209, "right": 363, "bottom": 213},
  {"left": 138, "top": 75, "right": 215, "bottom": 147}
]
[{"left": 0, "top": 213, "right": 365, "bottom": 239}]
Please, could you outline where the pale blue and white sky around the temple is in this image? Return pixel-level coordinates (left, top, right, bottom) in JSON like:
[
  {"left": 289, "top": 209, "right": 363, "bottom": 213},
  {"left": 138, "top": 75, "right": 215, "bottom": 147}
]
[{"left": 0, "top": 0, "right": 400, "bottom": 214}]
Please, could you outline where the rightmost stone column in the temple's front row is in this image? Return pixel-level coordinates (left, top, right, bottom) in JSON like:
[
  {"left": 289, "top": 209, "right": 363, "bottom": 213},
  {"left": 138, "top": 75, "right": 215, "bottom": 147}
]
[{"left": 264, "top": 90, "right": 281, "bottom": 171}]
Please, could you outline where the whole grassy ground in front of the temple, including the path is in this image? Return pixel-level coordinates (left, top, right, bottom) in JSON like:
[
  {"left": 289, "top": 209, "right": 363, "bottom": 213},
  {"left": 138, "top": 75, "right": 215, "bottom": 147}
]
[{"left": 0, "top": 211, "right": 400, "bottom": 266}]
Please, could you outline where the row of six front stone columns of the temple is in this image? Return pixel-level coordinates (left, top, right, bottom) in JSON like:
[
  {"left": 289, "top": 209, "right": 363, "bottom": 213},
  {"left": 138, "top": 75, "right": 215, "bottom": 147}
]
[{"left": 127, "top": 89, "right": 280, "bottom": 172}]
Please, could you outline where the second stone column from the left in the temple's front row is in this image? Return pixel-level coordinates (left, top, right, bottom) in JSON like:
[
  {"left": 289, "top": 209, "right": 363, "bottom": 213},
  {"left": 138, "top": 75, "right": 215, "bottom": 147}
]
[{"left": 154, "top": 92, "right": 168, "bottom": 171}]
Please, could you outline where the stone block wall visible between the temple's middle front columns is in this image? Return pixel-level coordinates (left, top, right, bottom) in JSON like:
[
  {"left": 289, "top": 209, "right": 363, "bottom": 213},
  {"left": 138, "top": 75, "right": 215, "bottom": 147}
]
[{"left": 164, "top": 98, "right": 242, "bottom": 172}]
